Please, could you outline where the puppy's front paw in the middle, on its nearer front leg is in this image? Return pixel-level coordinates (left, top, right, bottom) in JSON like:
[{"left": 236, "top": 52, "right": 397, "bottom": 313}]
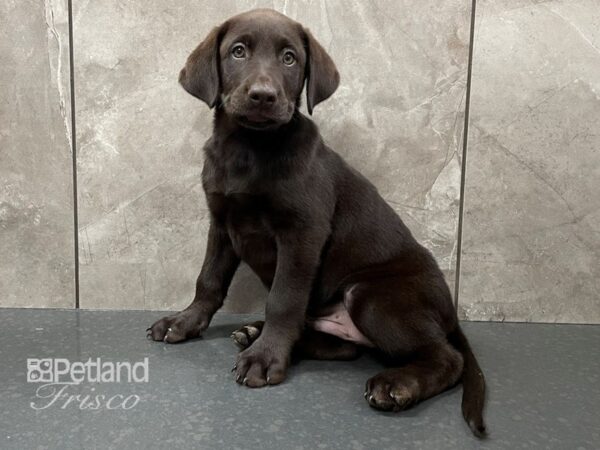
[{"left": 234, "top": 341, "right": 289, "bottom": 387}]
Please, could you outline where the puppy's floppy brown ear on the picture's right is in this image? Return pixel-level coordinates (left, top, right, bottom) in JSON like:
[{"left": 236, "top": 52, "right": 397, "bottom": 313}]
[{"left": 304, "top": 28, "right": 340, "bottom": 114}]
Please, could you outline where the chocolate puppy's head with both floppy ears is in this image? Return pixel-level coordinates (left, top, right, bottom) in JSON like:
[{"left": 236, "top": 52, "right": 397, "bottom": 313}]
[{"left": 179, "top": 9, "right": 339, "bottom": 130}]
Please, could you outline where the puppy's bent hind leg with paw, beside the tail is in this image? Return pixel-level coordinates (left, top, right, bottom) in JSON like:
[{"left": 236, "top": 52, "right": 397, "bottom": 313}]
[{"left": 344, "top": 277, "right": 463, "bottom": 411}]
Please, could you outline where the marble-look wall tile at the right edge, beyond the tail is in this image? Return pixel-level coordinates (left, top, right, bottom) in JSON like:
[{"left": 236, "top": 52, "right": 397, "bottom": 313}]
[{"left": 459, "top": 0, "right": 600, "bottom": 323}]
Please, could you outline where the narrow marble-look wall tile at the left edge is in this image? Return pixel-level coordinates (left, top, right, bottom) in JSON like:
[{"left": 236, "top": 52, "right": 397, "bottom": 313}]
[{"left": 0, "top": 0, "right": 75, "bottom": 308}]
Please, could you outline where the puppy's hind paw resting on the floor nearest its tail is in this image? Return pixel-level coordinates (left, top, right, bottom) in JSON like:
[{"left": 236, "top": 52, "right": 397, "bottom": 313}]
[{"left": 365, "top": 370, "right": 418, "bottom": 411}]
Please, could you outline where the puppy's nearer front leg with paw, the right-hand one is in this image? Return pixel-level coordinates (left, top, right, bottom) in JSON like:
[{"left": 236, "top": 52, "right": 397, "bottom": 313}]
[{"left": 235, "top": 233, "right": 324, "bottom": 387}]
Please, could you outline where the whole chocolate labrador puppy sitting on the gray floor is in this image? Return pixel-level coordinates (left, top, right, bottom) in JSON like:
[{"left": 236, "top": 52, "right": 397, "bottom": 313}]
[{"left": 148, "top": 9, "right": 485, "bottom": 436}]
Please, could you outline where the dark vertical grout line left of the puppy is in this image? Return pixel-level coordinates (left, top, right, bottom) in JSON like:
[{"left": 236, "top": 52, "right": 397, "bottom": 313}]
[{"left": 67, "top": 0, "right": 79, "bottom": 309}]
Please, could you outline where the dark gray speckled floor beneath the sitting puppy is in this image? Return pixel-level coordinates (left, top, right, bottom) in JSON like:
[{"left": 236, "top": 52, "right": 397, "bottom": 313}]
[{"left": 0, "top": 309, "right": 600, "bottom": 450}]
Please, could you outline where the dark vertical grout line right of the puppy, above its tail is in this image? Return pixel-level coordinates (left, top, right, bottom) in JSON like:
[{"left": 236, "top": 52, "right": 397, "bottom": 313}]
[{"left": 454, "top": 0, "right": 477, "bottom": 311}]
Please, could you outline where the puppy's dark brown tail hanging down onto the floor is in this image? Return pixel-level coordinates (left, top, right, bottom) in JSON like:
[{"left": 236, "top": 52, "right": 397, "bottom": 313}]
[{"left": 448, "top": 325, "right": 486, "bottom": 438}]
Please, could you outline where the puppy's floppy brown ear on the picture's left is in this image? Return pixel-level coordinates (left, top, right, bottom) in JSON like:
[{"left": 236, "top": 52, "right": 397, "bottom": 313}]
[{"left": 179, "top": 26, "right": 224, "bottom": 108}]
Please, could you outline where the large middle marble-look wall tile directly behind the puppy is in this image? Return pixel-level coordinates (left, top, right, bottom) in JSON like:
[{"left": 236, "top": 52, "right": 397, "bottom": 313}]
[{"left": 73, "top": 0, "right": 470, "bottom": 311}]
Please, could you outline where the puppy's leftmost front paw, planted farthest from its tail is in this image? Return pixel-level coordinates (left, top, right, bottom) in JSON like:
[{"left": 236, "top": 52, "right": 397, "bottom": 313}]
[{"left": 146, "top": 310, "right": 209, "bottom": 344}]
